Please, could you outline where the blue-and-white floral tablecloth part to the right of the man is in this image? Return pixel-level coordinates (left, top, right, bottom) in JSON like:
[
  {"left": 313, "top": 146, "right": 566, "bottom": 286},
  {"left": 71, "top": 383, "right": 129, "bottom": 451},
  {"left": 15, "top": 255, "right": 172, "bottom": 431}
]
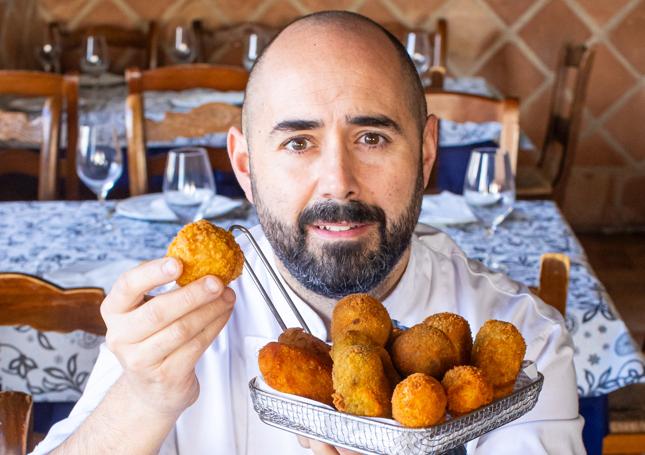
[{"left": 442, "top": 201, "right": 645, "bottom": 396}]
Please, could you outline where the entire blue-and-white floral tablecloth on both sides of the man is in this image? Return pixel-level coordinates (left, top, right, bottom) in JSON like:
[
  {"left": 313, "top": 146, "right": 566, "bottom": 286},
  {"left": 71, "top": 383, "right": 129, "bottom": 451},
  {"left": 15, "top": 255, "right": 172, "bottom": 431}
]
[{"left": 0, "top": 201, "right": 645, "bottom": 401}]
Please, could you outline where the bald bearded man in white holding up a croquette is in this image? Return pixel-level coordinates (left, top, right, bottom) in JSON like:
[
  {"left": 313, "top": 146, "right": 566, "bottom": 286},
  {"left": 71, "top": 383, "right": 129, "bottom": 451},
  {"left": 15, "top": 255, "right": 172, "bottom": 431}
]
[{"left": 31, "top": 12, "right": 584, "bottom": 454}]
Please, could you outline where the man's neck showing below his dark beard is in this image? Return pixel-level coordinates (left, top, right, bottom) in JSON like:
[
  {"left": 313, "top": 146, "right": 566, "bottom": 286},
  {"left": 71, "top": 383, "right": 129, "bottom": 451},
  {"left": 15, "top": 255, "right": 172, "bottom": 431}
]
[{"left": 276, "top": 246, "right": 411, "bottom": 332}]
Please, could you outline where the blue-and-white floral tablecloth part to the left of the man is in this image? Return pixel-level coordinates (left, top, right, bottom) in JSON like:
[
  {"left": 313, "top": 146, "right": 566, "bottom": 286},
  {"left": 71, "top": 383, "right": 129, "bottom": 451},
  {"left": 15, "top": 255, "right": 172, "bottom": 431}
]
[{"left": 0, "top": 201, "right": 257, "bottom": 401}]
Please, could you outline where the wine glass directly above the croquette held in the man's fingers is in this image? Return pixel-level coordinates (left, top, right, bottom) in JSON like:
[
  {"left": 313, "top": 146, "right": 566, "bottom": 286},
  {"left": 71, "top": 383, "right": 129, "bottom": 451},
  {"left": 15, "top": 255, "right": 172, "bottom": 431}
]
[{"left": 163, "top": 147, "right": 215, "bottom": 224}]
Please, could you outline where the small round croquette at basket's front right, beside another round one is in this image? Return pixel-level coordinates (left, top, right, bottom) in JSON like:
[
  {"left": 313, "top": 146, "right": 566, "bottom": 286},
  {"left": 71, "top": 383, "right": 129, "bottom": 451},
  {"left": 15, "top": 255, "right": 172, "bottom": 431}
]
[{"left": 441, "top": 365, "right": 493, "bottom": 416}]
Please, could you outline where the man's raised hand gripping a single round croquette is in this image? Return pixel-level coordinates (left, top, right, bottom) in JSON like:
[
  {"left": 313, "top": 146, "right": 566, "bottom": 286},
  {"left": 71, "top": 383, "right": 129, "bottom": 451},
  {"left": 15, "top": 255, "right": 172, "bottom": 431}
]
[{"left": 101, "top": 258, "right": 235, "bottom": 416}]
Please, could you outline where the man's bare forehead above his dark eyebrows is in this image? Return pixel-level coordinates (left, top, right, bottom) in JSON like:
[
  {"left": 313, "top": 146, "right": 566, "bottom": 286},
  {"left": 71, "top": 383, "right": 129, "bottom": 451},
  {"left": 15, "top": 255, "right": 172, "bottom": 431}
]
[{"left": 252, "top": 22, "right": 405, "bottom": 126}]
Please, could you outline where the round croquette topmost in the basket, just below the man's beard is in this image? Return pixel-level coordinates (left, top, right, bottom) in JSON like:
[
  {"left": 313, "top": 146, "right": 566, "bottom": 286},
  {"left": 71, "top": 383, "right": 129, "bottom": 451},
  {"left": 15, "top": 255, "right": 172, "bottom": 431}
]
[{"left": 331, "top": 294, "right": 392, "bottom": 346}]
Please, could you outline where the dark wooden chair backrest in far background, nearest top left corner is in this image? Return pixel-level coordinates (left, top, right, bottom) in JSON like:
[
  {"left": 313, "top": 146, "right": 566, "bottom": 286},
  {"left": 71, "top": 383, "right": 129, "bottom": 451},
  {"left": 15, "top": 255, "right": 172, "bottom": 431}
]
[{"left": 49, "top": 21, "right": 159, "bottom": 72}]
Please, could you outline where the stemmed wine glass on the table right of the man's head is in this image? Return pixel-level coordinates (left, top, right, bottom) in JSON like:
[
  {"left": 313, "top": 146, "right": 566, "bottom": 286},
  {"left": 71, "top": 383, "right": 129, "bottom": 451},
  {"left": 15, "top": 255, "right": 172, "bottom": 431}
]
[{"left": 464, "top": 147, "right": 515, "bottom": 271}]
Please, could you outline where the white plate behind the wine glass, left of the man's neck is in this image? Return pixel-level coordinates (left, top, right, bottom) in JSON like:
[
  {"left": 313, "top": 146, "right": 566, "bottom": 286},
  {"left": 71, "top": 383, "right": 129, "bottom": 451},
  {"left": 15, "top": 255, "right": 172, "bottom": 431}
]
[{"left": 116, "top": 193, "right": 244, "bottom": 221}]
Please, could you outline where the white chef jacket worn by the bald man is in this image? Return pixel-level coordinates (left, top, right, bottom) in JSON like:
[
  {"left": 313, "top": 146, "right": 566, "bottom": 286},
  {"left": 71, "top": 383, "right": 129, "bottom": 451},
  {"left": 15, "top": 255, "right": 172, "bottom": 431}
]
[{"left": 33, "top": 226, "right": 585, "bottom": 455}]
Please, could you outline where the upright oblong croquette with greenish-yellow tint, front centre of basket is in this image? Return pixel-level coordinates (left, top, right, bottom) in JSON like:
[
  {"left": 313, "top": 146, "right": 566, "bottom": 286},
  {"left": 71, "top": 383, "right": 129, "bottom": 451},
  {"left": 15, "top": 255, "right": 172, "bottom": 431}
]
[{"left": 332, "top": 345, "right": 392, "bottom": 417}]
